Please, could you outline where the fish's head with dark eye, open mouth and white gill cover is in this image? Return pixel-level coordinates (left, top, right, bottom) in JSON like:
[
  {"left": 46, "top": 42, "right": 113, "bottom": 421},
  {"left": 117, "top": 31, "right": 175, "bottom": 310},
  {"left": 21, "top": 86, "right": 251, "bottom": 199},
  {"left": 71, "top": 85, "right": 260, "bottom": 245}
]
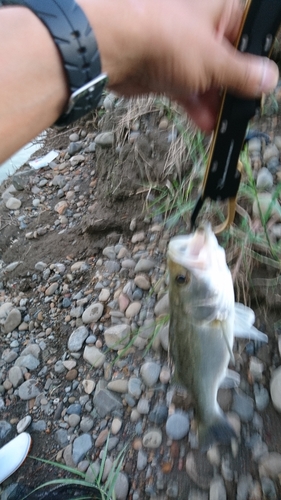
[{"left": 168, "top": 223, "right": 234, "bottom": 320}]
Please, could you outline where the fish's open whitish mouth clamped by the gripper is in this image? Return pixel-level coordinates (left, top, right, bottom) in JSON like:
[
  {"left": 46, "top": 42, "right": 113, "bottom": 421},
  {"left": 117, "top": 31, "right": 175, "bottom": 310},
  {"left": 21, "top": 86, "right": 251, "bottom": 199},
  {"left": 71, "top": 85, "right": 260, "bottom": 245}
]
[{"left": 168, "top": 223, "right": 214, "bottom": 269}]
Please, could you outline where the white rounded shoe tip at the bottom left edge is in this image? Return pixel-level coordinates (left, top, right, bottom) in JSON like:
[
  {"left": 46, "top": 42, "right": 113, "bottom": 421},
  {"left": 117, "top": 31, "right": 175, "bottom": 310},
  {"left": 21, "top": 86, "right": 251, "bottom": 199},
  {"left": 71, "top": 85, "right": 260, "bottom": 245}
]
[{"left": 0, "top": 432, "right": 31, "bottom": 484}]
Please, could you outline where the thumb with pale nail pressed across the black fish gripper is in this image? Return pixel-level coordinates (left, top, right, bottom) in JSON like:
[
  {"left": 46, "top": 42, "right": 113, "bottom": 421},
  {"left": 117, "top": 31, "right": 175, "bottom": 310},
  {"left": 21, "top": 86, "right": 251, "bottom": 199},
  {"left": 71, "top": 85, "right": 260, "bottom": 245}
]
[{"left": 213, "top": 46, "right": 279, "bottom": 98}]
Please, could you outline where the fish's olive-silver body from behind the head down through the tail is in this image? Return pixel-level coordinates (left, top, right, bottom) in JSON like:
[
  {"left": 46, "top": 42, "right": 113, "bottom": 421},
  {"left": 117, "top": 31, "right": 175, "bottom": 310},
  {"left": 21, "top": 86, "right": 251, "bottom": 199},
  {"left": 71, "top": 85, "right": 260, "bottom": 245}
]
[{"left": 170, "top": 314, "right": 234, "bottom": 446}]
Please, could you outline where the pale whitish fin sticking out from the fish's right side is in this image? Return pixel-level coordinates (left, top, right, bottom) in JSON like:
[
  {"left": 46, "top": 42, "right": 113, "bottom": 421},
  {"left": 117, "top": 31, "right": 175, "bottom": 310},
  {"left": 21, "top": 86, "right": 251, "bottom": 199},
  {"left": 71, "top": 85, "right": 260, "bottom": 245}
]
[{"left": 234, "top": 303, "right": 268, "bottom": 342}]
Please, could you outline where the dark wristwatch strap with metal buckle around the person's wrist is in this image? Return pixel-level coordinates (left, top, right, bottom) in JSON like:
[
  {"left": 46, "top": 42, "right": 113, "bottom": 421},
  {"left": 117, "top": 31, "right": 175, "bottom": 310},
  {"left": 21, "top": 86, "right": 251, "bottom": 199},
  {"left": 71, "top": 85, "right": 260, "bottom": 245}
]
[{"left": 0, "top": 0, "right": 107, "bottom": 127}]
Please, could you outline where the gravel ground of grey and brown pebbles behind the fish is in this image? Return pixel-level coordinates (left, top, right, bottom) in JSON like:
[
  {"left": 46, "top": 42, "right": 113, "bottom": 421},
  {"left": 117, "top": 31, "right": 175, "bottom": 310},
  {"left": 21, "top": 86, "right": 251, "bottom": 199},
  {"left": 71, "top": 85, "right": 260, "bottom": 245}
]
[{"left": 0, "top": 91, "right": 281, "bottom": 500}]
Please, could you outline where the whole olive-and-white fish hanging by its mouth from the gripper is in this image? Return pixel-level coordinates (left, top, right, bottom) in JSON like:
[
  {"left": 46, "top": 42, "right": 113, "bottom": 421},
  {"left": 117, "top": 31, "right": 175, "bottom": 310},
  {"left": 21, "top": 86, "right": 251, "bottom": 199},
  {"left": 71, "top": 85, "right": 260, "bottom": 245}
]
[{"left": 167, "top": 223, "right": 268, "bottom": 450}]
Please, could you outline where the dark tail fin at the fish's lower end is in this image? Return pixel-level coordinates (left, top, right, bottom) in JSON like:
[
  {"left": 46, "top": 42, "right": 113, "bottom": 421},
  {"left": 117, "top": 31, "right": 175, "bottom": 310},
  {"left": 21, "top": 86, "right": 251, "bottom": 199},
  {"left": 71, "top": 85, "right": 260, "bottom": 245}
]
[{"left": 198, "top": 415, "right": 237, "bottom": 451}]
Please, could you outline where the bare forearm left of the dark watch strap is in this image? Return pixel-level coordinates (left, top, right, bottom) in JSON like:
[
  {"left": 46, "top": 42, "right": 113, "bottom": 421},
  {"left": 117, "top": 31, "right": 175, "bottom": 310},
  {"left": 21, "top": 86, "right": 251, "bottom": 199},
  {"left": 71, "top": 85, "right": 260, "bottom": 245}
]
[{"left": 0, "top": 7, "right": 68, "bottom": 163}]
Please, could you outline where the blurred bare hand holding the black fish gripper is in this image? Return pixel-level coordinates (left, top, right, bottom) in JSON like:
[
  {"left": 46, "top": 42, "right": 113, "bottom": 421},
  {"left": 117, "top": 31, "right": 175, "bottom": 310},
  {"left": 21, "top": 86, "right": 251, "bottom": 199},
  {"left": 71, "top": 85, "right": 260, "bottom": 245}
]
[{"left": 82, "top": 0, "right": 278, "bottom": 131}]
